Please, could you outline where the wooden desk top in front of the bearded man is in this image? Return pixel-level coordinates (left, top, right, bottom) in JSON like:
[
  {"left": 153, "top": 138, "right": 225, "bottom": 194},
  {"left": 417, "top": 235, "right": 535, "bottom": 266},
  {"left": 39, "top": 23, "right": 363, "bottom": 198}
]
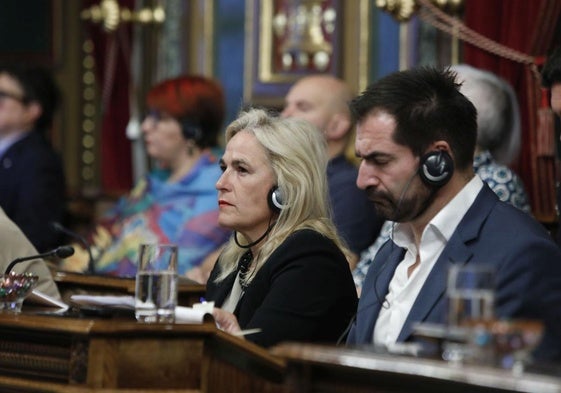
[{"left": 271, "top": 343, "right": 561, "bottom": 393}]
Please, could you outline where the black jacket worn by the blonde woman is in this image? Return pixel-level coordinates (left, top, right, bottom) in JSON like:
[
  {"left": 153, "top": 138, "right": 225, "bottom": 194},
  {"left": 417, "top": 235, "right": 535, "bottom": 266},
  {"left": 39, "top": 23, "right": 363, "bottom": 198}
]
[{"left": 206, "top": 230, "right": 357, "bottom": 347}]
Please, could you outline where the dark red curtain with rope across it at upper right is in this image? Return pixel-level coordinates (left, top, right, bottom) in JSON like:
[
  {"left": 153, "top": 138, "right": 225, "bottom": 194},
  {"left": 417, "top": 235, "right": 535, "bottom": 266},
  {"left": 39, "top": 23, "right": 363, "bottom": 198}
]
[{"left": 464, "top": 0, "right": 561, "bottom": 222}]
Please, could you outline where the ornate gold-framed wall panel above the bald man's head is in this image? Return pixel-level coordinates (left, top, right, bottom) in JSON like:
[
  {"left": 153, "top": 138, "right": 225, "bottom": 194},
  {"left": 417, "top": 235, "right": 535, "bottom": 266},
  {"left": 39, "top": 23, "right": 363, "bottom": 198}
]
[{"left": 244, "top": 0, "right": 344, "bottom": 107}]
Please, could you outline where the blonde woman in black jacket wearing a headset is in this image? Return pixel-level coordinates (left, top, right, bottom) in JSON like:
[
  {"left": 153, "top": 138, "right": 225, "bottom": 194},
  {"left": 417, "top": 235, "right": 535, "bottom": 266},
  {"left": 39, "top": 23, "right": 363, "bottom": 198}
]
[{"left": 207, "top": 109, "right": 357, "bottom": 347}]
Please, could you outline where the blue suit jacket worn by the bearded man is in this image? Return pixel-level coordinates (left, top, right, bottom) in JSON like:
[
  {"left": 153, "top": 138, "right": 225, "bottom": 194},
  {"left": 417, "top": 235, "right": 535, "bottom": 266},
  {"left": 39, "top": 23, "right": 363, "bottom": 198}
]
[{"left": 347, "top": 185, "right": 561, "bottom": 359}]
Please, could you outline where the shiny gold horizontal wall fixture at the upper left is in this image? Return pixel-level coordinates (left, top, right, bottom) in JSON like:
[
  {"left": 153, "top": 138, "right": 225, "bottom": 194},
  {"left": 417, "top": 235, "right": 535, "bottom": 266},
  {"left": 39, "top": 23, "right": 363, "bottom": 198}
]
[{"left": 81, "top": 0, "right": 166, "bottom": 32}]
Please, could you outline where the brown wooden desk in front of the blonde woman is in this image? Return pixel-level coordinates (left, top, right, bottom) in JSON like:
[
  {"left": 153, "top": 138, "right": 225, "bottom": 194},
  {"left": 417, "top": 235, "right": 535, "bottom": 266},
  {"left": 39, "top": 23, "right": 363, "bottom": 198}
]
[{"left": 0, "top": 312, "right": 284, "bottom": 393}]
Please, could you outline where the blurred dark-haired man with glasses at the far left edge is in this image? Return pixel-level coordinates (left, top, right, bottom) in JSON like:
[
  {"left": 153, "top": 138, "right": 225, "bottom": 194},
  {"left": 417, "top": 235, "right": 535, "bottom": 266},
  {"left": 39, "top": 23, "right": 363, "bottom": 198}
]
[{"left": 0, "top": 64, "right": 66, "bottom": 252}]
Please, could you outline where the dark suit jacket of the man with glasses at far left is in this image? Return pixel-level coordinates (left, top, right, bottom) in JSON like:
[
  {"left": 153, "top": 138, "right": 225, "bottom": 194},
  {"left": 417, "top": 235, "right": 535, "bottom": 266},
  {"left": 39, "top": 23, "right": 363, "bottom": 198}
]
[{"left": 0, "top": 131, "right": 65, "bottom": 250}]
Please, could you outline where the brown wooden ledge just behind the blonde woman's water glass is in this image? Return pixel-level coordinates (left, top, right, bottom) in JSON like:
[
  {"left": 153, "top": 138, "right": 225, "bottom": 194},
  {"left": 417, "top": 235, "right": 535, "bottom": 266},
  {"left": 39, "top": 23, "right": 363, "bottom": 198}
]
[{"left": 53, "top": 271, "right": 206, "bottom": 307}]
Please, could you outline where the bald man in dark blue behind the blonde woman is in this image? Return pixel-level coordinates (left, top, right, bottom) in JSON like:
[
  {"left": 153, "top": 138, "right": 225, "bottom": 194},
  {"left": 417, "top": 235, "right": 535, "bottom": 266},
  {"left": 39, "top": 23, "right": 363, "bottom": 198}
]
[{"left": 281, "top": 74, "right": 383, "bottom": 268}]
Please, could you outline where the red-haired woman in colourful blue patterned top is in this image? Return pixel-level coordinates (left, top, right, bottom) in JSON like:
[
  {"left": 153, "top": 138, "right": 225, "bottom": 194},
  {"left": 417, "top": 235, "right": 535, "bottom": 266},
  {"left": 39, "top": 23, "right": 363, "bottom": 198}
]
[{"left": 65, "top": 76, "right": 230, "bottom": 282}]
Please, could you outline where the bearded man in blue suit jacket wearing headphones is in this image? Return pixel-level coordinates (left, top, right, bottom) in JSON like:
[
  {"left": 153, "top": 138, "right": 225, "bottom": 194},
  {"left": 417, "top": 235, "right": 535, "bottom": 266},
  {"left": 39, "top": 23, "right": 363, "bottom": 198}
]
[{"left": 347, "top": 68, "right": 561, "bottom": 360}]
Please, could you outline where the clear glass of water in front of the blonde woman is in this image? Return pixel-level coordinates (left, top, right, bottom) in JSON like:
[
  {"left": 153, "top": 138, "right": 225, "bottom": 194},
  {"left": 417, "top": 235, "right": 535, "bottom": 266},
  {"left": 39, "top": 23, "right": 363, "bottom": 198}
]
[{"left": 135, "top": 244, "right": 177, "bottom": 323}]
